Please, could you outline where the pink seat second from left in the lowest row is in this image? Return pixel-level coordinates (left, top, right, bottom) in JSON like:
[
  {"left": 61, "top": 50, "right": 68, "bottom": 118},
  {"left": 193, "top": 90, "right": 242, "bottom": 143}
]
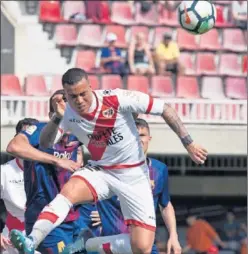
[{"left": 25, "top": 75, "right": 49, "bottom": 96}]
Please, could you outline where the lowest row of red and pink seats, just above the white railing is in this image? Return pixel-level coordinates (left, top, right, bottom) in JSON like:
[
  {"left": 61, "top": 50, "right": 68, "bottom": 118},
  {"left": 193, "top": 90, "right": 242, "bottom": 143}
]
[{"left": 1, "top": 75, "right": 247, "bottom": 99}]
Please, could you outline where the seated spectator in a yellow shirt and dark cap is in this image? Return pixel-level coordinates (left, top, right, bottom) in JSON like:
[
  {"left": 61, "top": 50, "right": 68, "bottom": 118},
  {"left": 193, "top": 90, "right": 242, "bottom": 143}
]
[{"left": 156, "top": 33, "right": 184, "bottom": 75}]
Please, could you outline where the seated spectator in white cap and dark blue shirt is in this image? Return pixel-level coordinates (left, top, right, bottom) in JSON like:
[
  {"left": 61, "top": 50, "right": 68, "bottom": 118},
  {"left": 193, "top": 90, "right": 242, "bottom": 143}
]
[{"left": 101, "top": 33, "right": 127, "bottom": 77}]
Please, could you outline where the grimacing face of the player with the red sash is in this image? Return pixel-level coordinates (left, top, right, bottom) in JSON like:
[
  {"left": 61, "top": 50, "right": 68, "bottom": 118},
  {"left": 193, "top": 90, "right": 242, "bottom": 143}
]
[{"left": 64, "top": 78, "right": 93, "bottom": 115}]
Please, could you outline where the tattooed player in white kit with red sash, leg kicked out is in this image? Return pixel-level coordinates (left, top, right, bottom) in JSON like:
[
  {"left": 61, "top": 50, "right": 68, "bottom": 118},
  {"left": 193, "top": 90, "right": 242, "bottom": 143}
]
[{"left": 11, "top": 68, "right": 207, "bottom": 254}]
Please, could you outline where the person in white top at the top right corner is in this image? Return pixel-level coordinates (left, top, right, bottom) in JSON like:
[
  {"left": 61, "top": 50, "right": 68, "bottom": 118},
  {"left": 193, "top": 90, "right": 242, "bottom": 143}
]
[{"left": 231, "top": 1, "right": 247, "bottom": 30}]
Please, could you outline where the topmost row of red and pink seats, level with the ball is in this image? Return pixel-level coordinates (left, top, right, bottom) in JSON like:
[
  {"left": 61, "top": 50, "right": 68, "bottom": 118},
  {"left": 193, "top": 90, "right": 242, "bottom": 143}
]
[{"left": 39, "top": 1, "right": 230, "bottom": 26}]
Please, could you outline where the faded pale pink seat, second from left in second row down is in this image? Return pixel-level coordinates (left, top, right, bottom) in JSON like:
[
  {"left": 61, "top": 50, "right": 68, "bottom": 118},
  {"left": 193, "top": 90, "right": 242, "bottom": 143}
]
[{"left": 77, "top": 25, "right": 103, "bottom": 47}]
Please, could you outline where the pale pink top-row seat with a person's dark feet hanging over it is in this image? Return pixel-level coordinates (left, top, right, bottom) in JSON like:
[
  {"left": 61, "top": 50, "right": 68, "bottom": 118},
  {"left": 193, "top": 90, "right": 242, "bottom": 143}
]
[{"left": 135, "top": 3, "right": 158, "bottom": 26}]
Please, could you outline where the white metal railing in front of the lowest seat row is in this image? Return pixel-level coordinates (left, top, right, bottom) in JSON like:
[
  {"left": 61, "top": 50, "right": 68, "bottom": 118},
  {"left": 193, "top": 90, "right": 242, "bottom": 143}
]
[{"left": 1, "top": 96, "right": 247, "bottom": 126}]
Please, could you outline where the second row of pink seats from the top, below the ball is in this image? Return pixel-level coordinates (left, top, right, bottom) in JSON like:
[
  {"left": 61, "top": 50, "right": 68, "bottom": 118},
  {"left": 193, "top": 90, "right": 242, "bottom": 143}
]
[{"left": 55, "top": 24, "right": 247, "bottom": 52}]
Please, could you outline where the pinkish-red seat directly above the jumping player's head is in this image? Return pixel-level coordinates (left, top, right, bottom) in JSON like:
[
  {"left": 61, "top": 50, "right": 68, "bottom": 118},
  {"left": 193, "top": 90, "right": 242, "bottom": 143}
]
[{"left": 76, "top": 50, "right": 96, "bottom": 72}]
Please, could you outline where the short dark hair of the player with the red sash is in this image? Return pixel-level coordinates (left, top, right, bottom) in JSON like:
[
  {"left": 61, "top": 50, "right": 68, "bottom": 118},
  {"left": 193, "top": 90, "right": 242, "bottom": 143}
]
[{"left": 62, "top": 68, "right": 88, "bottom": 86}]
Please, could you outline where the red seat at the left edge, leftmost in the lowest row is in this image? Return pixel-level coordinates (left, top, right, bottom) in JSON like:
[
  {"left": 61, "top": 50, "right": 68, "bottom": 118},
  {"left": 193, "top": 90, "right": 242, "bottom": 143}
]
[{"left": 1, "top": 74, "right": 23, "bottom": 96}]
